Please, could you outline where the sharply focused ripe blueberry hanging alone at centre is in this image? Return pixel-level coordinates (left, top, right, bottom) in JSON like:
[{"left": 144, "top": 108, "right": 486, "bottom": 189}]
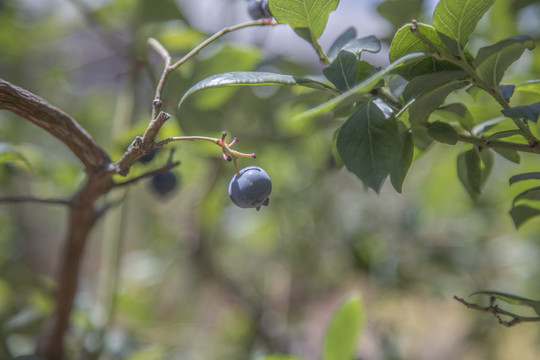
[{"left": 229, "top": 166, "right": 272, "bottom": 210}]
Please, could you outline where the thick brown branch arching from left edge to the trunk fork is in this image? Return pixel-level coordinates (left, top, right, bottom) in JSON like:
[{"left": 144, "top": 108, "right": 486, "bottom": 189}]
[{"left": 0, "top": 78, "right": 110, "bottom": 173}]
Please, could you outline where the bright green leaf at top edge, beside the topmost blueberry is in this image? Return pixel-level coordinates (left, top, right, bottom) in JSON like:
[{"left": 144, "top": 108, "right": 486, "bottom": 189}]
[{"left": 269, "top": 0, "right": 339, "bottom": 43}]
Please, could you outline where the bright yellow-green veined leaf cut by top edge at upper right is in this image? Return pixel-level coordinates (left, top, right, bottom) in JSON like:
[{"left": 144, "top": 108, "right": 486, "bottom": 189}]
[{"left": 433, "top": 0, "right": 495, "bottom": 47}]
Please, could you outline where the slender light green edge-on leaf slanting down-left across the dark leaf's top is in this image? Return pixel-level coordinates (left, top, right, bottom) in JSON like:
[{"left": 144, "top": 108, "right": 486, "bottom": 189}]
[{"left": 294, "top": 53, "right": 426, "bottom": 121}]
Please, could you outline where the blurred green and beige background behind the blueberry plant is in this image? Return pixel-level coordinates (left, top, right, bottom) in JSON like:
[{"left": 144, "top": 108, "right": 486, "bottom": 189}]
[{"left": 0, "top": 0, "right": 540, "bottom": 360}]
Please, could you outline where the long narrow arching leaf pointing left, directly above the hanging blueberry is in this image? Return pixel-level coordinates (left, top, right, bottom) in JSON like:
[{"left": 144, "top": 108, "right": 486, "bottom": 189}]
[{"left": 178, "top": 71, "right": 337, "bottom": 107}]
